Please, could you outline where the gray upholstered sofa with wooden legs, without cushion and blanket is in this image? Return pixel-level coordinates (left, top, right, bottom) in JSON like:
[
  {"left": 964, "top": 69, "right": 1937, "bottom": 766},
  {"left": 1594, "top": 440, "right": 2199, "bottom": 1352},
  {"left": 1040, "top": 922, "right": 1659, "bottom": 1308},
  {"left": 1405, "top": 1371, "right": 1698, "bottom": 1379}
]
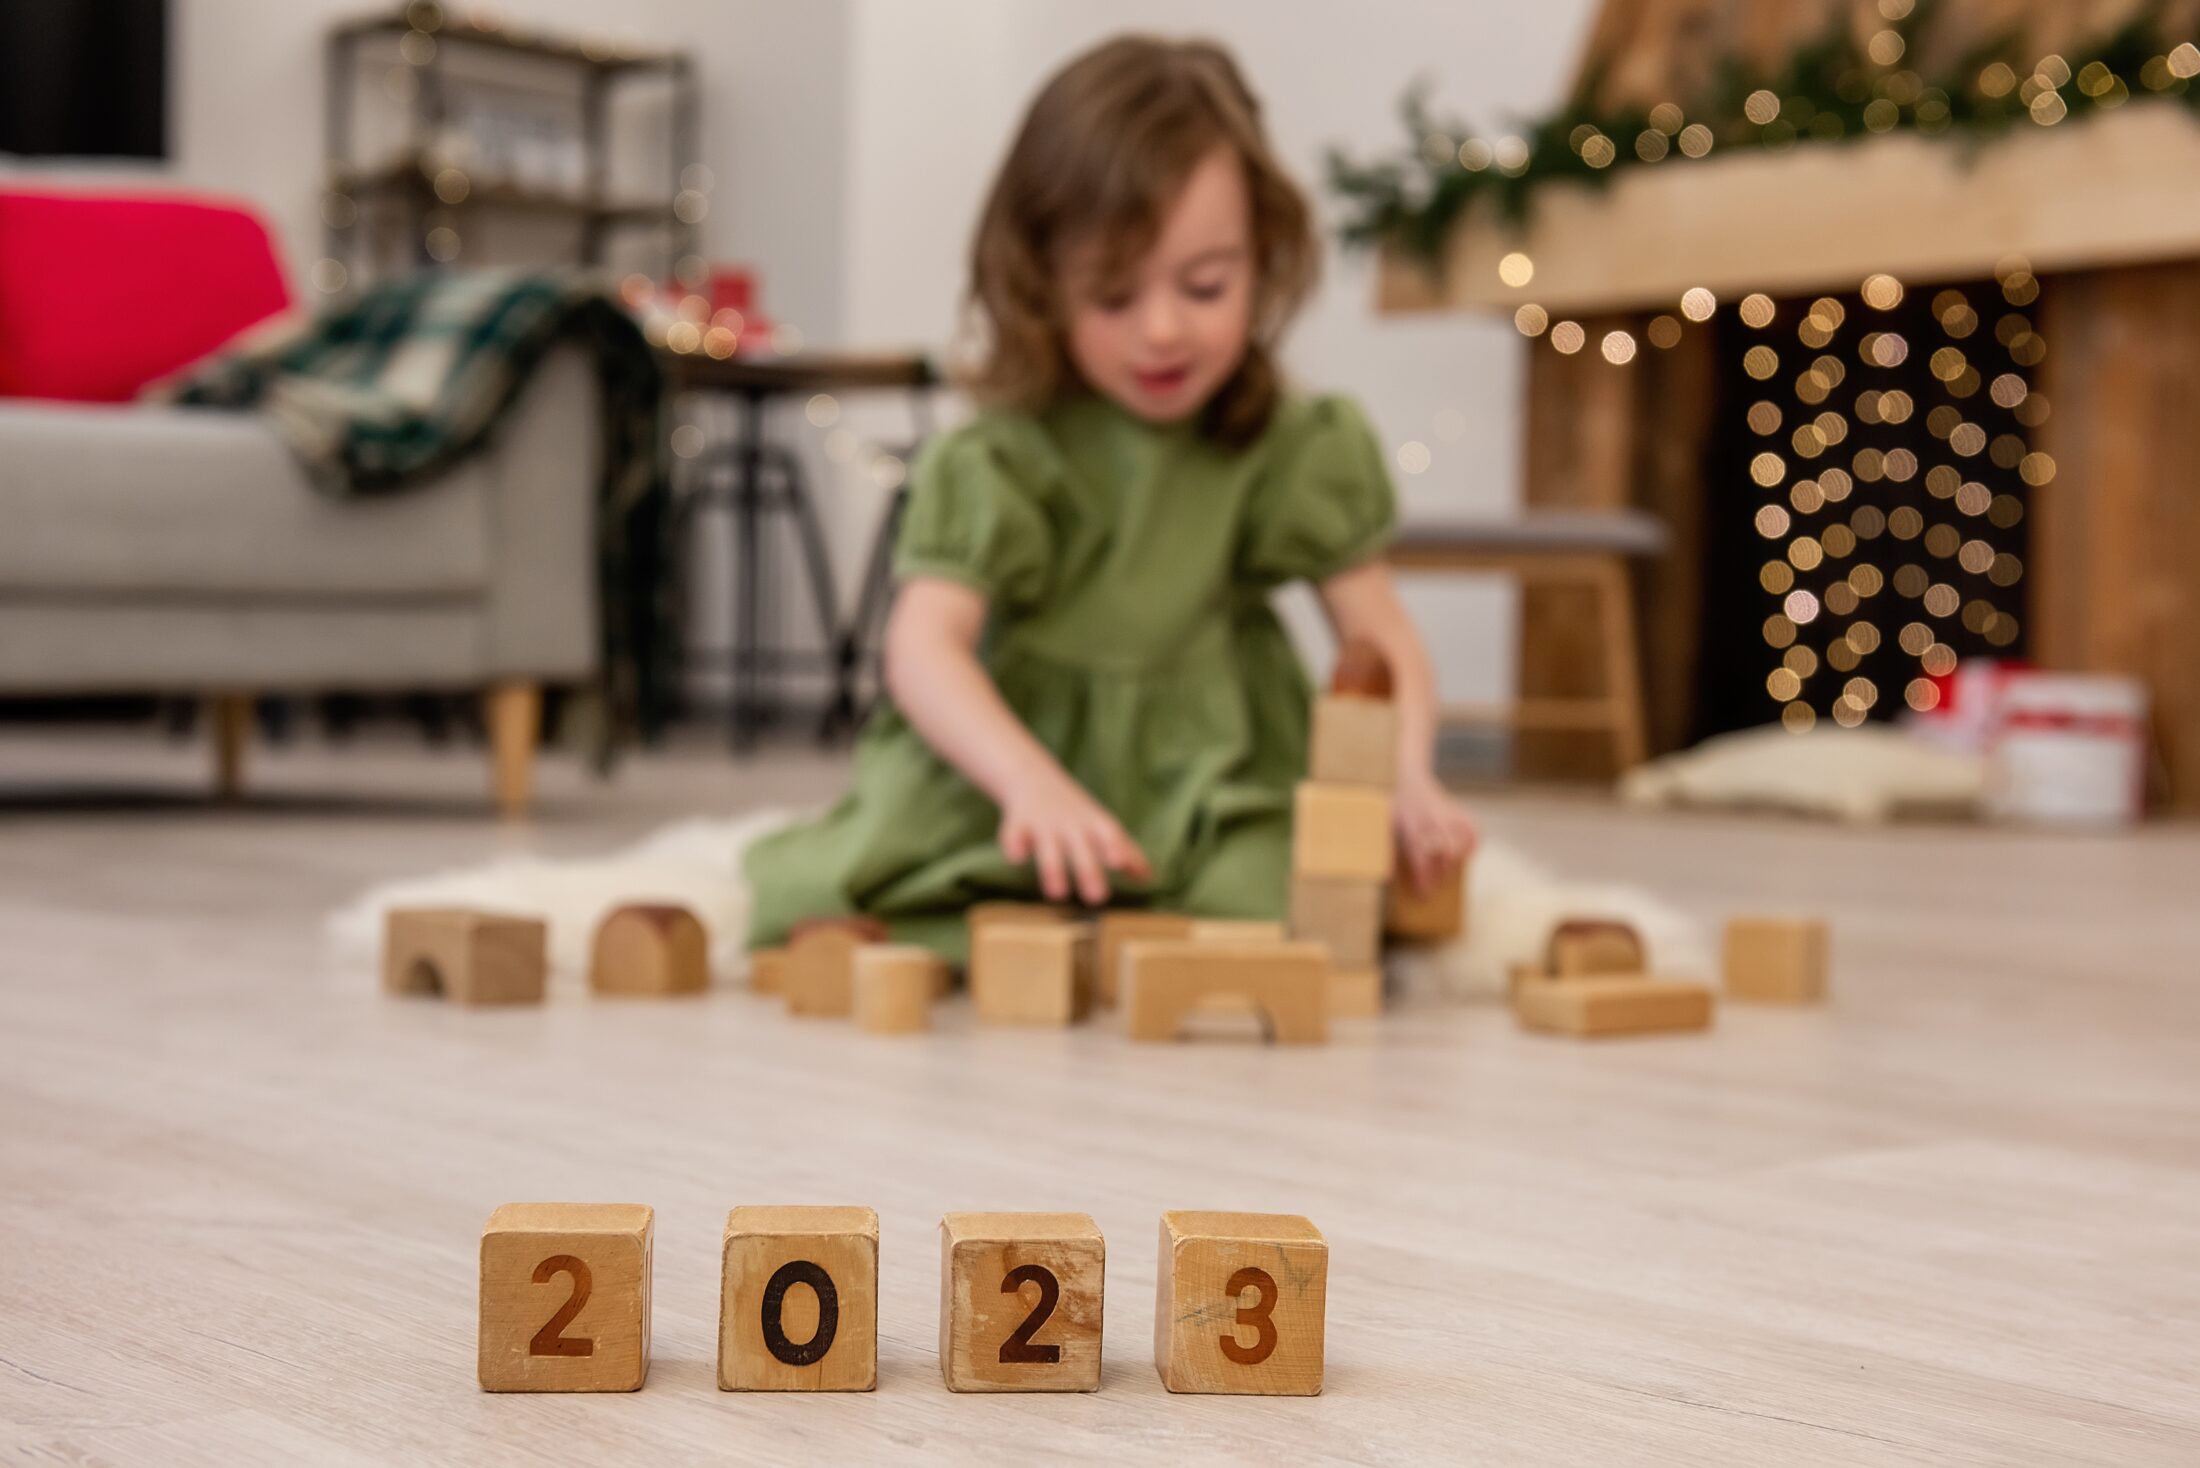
[{"left": 0, "top": 348, "right": 603, "bottom": 812}]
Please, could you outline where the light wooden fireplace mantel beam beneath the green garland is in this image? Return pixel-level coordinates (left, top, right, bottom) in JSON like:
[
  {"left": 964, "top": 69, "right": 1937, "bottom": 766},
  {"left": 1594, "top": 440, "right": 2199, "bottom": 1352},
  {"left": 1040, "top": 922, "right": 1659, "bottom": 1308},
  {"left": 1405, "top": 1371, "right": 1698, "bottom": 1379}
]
[{"left": 1377, "top": 99, "right": 2200, "bottom": 315}]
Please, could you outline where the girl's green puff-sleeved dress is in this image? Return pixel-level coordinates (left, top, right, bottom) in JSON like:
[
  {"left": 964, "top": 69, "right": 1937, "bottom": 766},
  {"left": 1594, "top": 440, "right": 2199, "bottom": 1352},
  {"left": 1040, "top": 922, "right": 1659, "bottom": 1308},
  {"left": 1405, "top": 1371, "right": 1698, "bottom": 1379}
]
[{"left": 746, "top": 396, "right": 1393, "bottom": 962}]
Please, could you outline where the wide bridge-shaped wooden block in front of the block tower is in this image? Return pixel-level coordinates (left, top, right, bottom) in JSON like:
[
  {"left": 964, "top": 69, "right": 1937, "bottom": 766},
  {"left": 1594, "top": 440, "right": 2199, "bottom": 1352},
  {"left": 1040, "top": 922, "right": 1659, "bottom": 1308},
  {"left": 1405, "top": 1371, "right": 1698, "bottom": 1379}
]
[{"left": 1124, "top": 940, "right": 1329, "bottom": 1043}]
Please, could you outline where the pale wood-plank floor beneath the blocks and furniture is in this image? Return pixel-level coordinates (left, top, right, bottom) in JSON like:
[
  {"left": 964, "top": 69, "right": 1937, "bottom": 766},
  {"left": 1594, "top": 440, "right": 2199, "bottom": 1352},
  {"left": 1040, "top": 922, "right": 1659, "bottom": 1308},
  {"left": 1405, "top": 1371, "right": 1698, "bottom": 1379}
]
[{"left": 0, "top": 737, "right": 2200, "bottom": 1468}]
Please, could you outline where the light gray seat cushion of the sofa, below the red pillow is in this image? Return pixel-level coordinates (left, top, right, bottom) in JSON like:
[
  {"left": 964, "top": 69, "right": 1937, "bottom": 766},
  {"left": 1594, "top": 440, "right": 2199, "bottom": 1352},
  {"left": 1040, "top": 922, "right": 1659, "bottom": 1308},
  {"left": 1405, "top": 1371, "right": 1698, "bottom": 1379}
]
[{"left": 0, "top": 403, "right": 491, "bottom": 599}]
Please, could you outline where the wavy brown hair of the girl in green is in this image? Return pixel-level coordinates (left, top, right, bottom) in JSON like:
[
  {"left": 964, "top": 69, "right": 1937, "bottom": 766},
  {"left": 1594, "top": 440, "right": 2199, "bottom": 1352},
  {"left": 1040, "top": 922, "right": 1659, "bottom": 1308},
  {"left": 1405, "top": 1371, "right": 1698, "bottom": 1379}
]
[{"left": 964, "top": 35, "right": 1320, "bottom": 442}]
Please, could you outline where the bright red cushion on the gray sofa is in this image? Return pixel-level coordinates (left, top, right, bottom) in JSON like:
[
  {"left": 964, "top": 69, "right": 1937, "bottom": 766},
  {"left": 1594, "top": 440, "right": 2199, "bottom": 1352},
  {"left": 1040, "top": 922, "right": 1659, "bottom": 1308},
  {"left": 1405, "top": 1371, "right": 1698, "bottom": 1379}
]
[{"left": 0, "top": 191, "right": 290, "bottom": 403}]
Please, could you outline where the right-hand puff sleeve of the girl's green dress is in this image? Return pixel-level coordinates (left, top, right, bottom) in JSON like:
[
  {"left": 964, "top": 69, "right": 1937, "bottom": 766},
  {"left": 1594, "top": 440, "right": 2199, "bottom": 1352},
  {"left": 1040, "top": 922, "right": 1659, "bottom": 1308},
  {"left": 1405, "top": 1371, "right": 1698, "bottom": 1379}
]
[{"left": 1236, "top": 396, "right": 1397, "bottom": 585}]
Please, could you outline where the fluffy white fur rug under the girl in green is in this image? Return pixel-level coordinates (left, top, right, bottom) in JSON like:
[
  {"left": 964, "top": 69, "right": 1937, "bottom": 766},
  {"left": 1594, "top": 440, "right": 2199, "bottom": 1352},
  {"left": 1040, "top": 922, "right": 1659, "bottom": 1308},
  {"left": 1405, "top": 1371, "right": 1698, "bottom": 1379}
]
[{"left": 328, "top": 810, "right": 1714, "bottom": 997}]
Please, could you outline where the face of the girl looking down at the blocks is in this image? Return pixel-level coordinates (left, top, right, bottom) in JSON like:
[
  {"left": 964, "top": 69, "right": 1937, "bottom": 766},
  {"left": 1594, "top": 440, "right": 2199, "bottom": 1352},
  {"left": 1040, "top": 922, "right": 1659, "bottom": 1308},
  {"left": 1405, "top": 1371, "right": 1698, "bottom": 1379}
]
[{"left": 1056, "top": 145, "right": 1254, "bottom": 423}]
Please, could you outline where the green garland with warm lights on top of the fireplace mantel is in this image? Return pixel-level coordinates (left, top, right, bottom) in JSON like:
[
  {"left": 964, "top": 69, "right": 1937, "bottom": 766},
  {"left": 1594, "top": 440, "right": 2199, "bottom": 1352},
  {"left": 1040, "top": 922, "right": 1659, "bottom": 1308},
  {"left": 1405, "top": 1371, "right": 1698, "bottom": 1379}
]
[{"left": 1329, "top": 0, "right": 2200, "bottom": 269}]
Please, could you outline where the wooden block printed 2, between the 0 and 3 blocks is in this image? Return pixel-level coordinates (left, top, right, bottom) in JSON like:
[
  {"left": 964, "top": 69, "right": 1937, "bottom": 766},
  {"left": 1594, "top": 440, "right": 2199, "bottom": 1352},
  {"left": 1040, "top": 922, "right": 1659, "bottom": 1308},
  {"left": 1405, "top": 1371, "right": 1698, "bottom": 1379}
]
[{"left": 939, "top": 1213, "right": 1107, "bottom": 1391}]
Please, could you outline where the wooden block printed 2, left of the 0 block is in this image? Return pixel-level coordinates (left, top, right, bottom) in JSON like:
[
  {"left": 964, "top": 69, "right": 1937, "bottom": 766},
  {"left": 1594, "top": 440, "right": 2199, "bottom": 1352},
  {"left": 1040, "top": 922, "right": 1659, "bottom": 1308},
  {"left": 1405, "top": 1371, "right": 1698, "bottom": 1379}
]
[{"left": 477, "top": 1204, "right": 656, "bottom": 1391}]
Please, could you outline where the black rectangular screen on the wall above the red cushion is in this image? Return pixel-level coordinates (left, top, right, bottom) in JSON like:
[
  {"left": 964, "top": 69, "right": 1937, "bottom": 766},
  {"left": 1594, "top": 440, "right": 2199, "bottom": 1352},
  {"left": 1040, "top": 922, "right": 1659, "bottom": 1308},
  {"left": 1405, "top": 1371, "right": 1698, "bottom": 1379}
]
[{"left": 0, "top": 0, "right": 167, "bottom": 158}]
